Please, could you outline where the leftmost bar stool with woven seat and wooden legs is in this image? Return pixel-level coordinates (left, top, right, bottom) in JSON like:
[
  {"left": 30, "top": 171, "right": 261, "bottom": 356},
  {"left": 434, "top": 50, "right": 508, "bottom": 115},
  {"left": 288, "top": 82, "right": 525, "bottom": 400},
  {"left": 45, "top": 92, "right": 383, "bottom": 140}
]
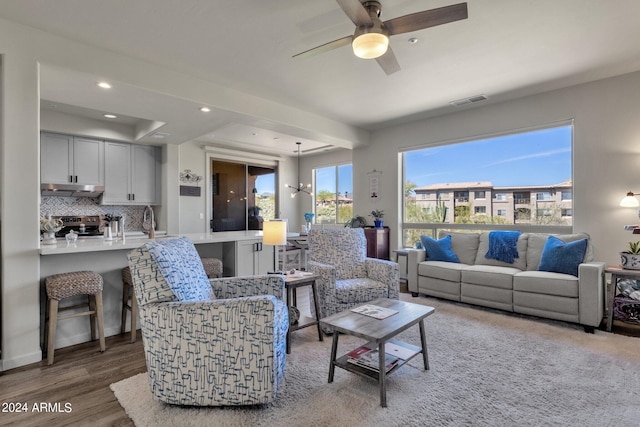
[{"left": 45, "top": 271, "right": 105, "bottom": 365}]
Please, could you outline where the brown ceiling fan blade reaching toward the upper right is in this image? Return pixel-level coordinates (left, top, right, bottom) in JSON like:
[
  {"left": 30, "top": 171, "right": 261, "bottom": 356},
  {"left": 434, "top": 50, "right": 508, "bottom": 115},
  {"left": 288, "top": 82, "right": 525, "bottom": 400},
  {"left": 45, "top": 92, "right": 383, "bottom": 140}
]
[{"left": 384, "top": 3, "right": 469, "bottom": 35}]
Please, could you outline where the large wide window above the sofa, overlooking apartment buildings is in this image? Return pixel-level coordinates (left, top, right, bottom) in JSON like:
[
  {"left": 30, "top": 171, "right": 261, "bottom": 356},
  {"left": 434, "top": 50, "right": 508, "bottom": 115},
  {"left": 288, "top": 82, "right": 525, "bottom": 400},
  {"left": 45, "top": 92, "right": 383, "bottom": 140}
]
[{"left": 402, "top": 123, "right": 574, "bottom": 246}]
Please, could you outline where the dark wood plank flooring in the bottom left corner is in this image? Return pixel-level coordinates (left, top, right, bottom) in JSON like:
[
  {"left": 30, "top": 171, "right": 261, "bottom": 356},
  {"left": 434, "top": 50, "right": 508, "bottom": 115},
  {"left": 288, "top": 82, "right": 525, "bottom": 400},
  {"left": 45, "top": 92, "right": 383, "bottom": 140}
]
[{"left": 0, "top": 331, "right": 146, "bottom": 427}]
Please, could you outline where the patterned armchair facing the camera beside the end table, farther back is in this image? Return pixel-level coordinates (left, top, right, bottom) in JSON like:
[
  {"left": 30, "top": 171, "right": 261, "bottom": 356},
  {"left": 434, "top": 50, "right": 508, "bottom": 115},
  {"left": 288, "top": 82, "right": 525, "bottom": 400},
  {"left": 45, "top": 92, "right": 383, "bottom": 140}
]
[{"left": 307, "top": 228, "right": 400, "bottom": 332}]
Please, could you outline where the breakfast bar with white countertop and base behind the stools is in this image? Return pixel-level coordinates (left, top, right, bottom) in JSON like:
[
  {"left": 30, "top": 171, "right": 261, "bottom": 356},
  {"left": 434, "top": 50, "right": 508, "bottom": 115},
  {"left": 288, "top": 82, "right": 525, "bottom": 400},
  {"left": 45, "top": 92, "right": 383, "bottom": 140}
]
[{"left": 40, "top": 230, "right": 274, "bottom": 351}]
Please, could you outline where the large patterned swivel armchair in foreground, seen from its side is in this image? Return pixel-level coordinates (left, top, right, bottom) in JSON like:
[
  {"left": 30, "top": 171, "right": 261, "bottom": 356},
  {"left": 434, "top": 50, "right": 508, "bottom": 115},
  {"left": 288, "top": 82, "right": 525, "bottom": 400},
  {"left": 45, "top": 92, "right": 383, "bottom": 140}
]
[{"left": 128, "top": 238, "right": 289, "bottom": 406}]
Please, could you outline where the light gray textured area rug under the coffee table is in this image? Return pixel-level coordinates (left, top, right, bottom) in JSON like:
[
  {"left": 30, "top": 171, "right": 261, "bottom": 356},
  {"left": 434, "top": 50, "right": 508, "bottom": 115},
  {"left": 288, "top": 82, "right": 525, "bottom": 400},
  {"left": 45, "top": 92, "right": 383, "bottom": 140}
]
[{"left": 111, "top": 294, "right": 640, "bottom": 427}]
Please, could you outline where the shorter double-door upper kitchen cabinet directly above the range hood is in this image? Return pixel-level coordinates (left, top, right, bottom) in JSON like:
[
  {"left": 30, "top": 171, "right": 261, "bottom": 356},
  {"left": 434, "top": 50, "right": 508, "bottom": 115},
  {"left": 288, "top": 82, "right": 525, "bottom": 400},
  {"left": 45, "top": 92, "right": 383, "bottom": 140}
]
[{"left": 40, "top": 132, "right": 104, "bottom": 185}]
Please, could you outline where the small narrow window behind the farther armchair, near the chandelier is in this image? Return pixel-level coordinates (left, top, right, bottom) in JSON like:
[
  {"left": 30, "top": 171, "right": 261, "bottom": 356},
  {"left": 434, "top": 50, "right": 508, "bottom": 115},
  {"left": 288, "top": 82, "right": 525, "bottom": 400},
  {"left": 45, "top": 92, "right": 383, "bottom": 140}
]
[{"left": 313, "top": 163, "right": 353, "bottom": 224}]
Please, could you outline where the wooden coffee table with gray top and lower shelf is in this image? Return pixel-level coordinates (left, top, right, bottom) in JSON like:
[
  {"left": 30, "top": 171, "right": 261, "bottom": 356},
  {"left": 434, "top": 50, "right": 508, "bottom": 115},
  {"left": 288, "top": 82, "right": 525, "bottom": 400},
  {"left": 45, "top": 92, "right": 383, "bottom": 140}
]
[{"left": 320, "top": 298, "right": 435, "bottom": 407}]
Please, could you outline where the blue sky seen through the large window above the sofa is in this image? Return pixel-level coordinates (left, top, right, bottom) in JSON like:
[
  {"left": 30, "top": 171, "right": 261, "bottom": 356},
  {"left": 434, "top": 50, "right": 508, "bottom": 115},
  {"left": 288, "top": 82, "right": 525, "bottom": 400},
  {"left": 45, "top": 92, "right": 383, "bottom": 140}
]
[{"left": 405, "top": 126, "right": 571, "bottom": 187}]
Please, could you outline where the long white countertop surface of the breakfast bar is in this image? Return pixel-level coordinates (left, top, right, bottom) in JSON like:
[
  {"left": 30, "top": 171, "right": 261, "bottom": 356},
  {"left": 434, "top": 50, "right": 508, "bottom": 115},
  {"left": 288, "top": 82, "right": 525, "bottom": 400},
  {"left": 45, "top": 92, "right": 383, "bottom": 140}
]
[{"left": 40, "top": 230, "right": 270, "bottom": 255}]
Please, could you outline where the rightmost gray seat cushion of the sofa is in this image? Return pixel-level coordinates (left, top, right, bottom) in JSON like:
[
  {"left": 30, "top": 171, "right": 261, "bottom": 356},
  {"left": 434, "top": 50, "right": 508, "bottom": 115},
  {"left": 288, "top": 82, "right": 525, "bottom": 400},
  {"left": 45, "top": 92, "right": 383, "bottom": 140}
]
[{"left": 513, "top": 271, "right": 578, "bottom": 298}]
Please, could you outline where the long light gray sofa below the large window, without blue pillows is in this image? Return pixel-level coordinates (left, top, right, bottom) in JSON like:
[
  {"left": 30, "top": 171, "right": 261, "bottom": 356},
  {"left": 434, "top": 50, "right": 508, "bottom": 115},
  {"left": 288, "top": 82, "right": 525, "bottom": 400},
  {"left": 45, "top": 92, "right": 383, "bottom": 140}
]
[{"left": 407, "top": 231, "right": 605, "bottom": 332}]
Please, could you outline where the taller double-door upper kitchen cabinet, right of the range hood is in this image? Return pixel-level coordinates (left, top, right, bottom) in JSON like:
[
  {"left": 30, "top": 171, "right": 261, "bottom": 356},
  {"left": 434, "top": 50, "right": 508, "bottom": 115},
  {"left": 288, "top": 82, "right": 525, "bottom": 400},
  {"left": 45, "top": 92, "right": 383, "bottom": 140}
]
[{"left": 102, "top": 141, "right": 159, "bottom": 205}]
